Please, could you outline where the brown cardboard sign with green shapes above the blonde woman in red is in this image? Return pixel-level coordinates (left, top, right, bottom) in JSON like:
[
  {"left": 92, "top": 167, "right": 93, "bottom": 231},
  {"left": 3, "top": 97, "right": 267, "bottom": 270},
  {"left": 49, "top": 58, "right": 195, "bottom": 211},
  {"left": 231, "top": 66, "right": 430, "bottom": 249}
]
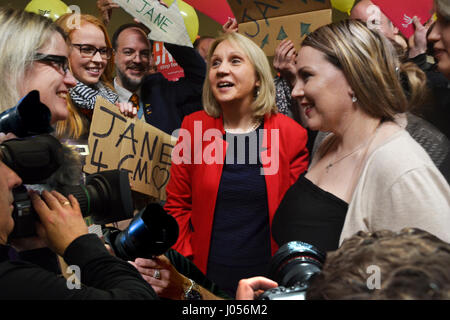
[{"left": 239, "top": 9, "right": 332, "bottom": 57}]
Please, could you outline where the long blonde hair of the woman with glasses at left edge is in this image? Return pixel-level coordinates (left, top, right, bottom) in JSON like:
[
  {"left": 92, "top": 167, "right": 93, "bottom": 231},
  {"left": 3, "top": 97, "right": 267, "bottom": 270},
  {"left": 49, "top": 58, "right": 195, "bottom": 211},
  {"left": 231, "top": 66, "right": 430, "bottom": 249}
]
[{"left": 0, "top": 8, "right": 67, "bottom": 111}]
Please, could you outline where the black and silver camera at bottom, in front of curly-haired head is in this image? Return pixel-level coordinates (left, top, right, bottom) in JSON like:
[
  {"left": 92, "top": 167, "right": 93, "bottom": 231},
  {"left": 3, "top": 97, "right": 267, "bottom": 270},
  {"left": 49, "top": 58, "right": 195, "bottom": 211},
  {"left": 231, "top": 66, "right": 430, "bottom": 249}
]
[{"left": 258, "top": 241, "right": 325, "bottom": 300}]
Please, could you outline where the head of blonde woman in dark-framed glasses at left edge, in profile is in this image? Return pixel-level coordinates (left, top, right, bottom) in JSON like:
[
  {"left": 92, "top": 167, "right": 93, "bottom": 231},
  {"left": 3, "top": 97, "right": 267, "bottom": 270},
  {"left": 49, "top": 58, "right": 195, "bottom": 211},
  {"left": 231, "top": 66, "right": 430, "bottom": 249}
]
[{"left": 0, "top": 9, "right": 75, "bottom": 124}]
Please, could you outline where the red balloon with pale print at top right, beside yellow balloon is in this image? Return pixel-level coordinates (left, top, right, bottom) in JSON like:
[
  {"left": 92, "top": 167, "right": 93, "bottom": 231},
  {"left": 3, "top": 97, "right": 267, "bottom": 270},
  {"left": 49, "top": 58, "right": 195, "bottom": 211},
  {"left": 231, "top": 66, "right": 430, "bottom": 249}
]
[{"left": 372, "top": 0, "right": 433, "bottom": 38}]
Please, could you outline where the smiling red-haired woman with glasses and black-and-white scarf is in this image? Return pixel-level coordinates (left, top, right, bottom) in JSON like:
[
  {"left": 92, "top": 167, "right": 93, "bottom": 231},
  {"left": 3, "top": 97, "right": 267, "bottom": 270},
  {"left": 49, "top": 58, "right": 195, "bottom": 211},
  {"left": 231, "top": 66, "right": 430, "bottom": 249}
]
[{"left": 56, "top": 14, "right": 118, "bottom": 139}]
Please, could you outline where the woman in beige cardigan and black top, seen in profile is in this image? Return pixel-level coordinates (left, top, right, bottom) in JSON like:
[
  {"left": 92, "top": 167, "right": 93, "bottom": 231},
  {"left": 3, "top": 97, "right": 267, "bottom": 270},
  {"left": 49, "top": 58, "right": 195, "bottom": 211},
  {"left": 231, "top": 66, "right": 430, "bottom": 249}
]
[{"left": 272, "top": 21, "right": 450, "bottom": 255}]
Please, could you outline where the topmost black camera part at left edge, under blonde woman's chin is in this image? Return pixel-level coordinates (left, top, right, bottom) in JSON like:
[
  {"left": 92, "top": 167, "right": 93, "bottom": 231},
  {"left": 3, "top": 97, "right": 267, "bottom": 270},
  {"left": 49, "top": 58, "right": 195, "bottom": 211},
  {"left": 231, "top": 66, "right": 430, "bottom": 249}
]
[{"left": 0, "top": 90, "right": 53, "bottom": 138}]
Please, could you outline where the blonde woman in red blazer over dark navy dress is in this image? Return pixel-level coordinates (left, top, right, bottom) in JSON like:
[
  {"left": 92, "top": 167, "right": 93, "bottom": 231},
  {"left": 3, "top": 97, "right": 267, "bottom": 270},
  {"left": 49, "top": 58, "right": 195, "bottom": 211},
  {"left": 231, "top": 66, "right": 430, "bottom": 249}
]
[{"left": 165, "top": 33, "right": 308, "bottom": 296}]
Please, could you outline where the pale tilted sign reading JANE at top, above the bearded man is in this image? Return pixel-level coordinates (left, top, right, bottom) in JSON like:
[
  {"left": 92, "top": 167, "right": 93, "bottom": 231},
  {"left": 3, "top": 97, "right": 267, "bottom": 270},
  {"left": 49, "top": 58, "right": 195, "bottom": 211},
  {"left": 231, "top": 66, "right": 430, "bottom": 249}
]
[{"left": 114, "top": 0, "right": 192, "bottom": 48}]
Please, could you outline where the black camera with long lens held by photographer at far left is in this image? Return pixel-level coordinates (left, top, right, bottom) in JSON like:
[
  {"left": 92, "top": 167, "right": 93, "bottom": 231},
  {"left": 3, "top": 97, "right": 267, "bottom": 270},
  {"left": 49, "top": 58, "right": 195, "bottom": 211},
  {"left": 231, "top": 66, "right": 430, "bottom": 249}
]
[{"left": 0, "top": 135, "right": 133, "bottom": 238}]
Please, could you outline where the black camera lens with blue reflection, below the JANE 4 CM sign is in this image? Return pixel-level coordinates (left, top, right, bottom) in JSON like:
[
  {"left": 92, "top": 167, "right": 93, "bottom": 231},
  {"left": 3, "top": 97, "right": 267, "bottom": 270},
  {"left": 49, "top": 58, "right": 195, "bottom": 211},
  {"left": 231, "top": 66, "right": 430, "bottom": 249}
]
[{"left": 103, "top": 203, "right": 178, "bottom": 261}]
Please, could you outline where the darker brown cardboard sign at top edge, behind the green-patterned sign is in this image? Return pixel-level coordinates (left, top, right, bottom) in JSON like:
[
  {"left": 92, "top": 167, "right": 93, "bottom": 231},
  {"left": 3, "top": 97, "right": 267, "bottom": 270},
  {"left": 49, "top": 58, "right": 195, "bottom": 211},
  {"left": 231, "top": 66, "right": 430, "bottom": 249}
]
[{"left": 228, "top": 0, "right": 331, "bottom": 23}]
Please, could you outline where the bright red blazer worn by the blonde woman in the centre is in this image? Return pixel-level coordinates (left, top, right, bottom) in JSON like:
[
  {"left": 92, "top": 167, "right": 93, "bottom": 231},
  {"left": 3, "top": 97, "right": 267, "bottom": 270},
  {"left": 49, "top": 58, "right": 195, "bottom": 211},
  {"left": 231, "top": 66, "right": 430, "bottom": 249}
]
[{"left": 164, "top": 111, "right": 308, "bottom": 274}]
